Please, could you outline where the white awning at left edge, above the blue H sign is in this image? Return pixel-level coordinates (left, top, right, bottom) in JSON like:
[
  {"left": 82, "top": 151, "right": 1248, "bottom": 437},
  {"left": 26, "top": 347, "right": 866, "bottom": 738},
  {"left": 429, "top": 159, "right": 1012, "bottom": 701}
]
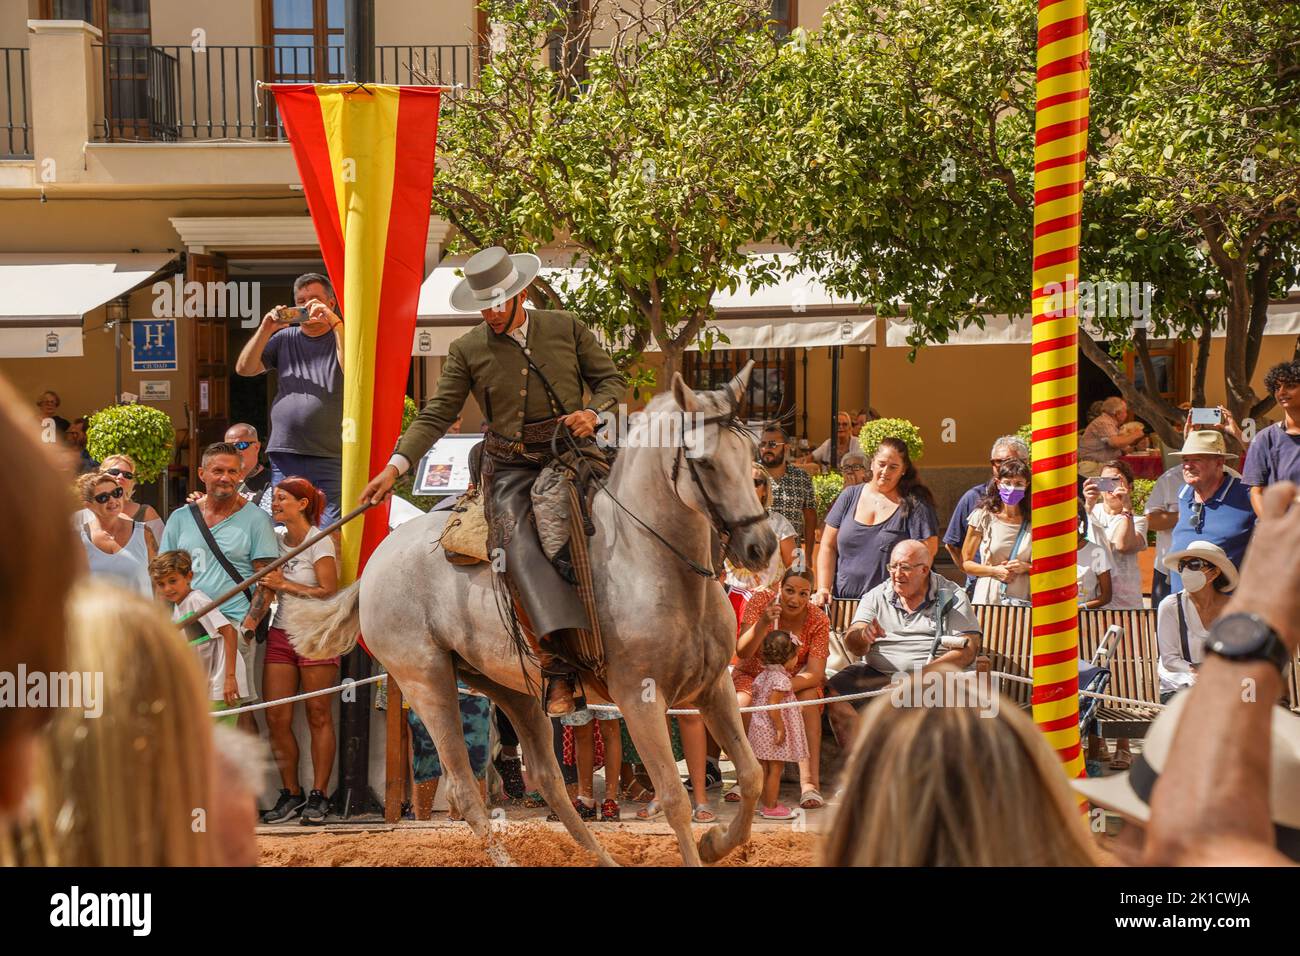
[{"left": 0, "top": 252, "right": 176, "bottom": 358}]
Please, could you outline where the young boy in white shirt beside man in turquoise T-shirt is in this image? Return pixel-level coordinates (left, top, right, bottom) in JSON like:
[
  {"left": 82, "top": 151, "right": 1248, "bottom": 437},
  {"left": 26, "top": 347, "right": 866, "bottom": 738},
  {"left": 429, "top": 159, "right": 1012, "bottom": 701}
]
[{"left": 150, "top": 551, "right": 248, "bottom": 726}]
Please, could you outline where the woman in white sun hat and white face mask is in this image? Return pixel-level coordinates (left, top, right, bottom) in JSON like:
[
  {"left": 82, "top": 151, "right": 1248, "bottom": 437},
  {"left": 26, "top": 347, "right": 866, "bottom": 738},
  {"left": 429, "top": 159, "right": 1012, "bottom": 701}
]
[{"left": 1156, "top": 541, "right": 1236, "bottom": 704}]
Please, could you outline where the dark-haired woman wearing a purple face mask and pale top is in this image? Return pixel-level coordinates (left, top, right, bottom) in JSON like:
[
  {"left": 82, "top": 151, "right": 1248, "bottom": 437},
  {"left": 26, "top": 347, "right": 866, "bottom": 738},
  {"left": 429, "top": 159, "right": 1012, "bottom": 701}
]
[{"left": 962, "top": 458, "right": 1034, "bottom": 605}]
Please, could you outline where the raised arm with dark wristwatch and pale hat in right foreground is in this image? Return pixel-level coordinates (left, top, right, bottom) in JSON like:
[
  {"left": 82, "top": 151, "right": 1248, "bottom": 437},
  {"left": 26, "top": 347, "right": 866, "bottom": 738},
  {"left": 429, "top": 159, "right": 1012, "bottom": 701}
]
[{"left": 1073, "top": 481, "right": 1300, "bottom": 866}]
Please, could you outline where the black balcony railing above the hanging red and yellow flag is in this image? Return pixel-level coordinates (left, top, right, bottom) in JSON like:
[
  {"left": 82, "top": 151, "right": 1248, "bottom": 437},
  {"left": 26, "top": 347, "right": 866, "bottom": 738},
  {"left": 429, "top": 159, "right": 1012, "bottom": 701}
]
[{"left": 94, "top": 43, "right": 472, "bottom": 142}]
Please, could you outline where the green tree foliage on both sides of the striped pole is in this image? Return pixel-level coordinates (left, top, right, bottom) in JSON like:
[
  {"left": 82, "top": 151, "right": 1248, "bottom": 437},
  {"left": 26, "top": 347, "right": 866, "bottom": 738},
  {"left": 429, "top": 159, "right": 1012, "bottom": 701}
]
[{"left": 787, "top": 0, "right": 1300, "bottom": 441}]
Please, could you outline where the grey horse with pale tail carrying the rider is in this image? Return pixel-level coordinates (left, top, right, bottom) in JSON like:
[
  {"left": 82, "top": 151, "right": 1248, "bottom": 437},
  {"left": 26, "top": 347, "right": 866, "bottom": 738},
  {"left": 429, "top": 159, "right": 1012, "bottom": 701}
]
[{"left": 286, "top": 363, "right": 777, "bottom": 866}]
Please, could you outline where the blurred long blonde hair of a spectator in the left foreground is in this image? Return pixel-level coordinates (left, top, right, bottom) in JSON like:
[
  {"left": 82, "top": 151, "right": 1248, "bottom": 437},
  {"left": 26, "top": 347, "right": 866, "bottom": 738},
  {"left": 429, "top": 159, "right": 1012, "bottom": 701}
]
[{"left": 0, "top": 581, "right": 220, "bottom": 866}]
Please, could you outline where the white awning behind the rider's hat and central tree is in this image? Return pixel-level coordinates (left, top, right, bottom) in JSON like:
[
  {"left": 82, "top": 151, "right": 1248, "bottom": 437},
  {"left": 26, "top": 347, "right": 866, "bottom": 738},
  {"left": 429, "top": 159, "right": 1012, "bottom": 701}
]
[{"left": 411, "top": 252, "right": 876, "bottom": 355}]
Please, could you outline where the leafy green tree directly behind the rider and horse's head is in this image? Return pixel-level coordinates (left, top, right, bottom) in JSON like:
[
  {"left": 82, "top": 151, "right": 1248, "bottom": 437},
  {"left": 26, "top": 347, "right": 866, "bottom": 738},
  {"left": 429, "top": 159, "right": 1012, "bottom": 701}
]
[{"left": 433, "top": 0, "right": 829, "bottom": 389}]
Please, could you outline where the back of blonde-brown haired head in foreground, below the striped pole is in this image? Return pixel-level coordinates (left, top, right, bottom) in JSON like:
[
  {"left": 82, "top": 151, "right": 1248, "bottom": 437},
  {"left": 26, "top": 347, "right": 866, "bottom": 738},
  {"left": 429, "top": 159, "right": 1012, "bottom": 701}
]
[{"left": 820, "top": 667, "right": 1097, "bottom": 866}]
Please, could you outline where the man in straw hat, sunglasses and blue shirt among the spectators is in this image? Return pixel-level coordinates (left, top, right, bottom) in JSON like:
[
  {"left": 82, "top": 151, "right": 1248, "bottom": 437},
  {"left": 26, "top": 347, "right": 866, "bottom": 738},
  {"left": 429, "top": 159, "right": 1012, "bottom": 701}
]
[{"left": 1169, "top": 429, "right": 1255, "bottom": 592}]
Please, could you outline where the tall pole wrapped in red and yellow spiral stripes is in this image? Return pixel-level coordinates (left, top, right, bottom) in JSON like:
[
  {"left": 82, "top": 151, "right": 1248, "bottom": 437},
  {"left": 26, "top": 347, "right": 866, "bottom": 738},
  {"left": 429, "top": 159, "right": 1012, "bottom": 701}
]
[{"left": 1031, "top": 0, "right": 1088, "bottom": 777}]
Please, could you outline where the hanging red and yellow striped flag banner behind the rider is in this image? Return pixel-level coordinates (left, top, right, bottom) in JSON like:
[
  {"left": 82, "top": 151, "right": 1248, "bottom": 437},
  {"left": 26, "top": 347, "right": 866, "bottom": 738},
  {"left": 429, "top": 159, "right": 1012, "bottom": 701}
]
[{"left": 269, "top": 83, "right": 441, "bottom": 584}]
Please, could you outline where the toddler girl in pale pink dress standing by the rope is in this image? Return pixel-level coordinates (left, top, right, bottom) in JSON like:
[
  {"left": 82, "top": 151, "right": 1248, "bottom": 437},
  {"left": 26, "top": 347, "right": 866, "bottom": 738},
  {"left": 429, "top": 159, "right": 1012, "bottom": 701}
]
[{"left": 749, "top": 631, "right": 809, "bottom": 819}]
